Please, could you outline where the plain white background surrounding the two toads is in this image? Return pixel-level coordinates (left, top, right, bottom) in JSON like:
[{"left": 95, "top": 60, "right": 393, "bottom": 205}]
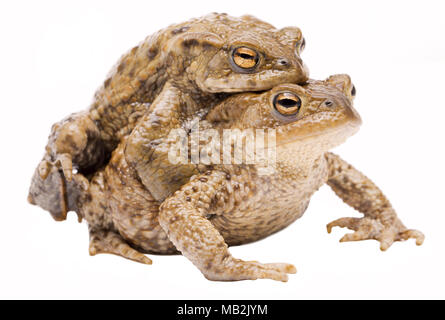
[{"left": 0, "top": 0, "right": 445, "bottom": 299}]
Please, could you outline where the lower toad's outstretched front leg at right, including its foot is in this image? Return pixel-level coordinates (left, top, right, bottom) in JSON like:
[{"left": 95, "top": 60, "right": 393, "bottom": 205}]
[{"left": 326, "top": 153, "right": 425, "bottom": 251}]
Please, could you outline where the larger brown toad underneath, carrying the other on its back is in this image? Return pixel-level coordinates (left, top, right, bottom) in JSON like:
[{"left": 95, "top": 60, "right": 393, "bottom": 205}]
[{"left": 28, "top": 75, "right": 424, "bottom": 281}]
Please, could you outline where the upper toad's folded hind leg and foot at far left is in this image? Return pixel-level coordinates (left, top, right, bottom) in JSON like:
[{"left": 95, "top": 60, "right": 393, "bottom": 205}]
[{"left": 28, "top": 112, "right": 104, "bottom": 220}]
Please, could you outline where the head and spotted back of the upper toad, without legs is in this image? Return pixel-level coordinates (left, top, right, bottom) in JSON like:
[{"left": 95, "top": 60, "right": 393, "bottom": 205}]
[{"left": 89, "top": 14, "right": 308, "bottom": 150}]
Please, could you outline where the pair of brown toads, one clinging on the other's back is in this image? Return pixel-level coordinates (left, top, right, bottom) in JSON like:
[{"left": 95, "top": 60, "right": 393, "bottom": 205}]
[{"left": 28, "top": 14, "right": 424, "bottom": 281}]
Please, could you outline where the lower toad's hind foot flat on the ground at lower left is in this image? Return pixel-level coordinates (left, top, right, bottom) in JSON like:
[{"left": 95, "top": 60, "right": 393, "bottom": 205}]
[{"left": 89, "top": 228, "right": 152, "bottom": 264}]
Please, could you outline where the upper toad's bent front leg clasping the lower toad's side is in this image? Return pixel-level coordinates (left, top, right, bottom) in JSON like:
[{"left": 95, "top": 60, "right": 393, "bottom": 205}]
[{"left": 125, "top": 82, "right": 198, "bottom": 201}]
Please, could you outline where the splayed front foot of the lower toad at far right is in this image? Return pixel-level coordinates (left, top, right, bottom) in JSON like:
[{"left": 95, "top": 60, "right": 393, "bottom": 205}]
[{"left": 326, "top": 217, "right": 425, "bottom": 251}]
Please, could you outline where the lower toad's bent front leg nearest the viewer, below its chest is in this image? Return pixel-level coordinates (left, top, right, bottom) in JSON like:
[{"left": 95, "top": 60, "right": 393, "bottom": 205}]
[{"left": 159, "top": 171, "right": 296, "bottom": 281}]
